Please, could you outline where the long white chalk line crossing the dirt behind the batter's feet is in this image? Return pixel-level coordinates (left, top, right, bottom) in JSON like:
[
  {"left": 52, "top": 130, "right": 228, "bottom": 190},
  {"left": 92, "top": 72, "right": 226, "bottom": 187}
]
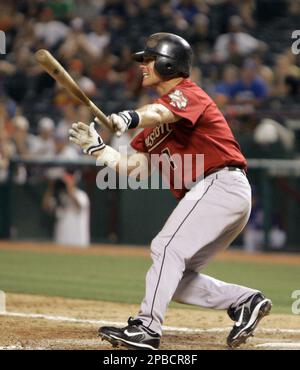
[{"left": 0, "top": 312, "right": 300, "bottom": 334}]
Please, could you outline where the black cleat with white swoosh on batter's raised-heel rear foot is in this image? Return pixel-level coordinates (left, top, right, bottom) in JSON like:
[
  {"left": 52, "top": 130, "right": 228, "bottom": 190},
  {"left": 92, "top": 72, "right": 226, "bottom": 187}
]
[{"left": 227, "top": 293, "right": 272, "bottom": 348}]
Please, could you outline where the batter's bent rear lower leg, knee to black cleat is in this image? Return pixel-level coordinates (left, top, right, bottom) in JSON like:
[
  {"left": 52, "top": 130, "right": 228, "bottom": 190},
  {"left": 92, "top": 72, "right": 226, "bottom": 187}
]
[{"left": 173, "top": 270, "right": 272, "bottom": 347}]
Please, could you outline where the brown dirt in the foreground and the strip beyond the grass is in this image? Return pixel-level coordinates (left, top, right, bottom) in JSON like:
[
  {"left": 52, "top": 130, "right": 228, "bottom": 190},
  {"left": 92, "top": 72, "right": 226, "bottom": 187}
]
[{"left": 0, "top": 242, "right": 300, "bottom": 350}]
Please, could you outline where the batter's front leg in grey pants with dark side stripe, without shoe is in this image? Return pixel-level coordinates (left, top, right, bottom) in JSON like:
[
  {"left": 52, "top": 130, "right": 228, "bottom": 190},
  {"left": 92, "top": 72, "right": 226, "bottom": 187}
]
[{"left": 138, "top": 171, "right": 251, "bottom": 334}]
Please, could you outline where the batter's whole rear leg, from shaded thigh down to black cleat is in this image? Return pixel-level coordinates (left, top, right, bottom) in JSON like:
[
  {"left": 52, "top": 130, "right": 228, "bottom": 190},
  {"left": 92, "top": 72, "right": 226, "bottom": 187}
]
[{"left": 173, "top": 178, "right": 272, "bottom": 347}]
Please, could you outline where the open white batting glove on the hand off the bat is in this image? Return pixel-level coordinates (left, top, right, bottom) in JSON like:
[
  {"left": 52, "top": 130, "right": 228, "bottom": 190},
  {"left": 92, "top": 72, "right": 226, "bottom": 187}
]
[{"left": 69, "top": 122, "right": 106, "bottom": 155}]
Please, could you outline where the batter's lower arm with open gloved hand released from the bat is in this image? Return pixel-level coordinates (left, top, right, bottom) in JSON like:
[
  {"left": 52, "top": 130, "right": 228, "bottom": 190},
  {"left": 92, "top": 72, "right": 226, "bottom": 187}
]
[{"left": 69, "top": 122, "right": 150, "bottom": 179}]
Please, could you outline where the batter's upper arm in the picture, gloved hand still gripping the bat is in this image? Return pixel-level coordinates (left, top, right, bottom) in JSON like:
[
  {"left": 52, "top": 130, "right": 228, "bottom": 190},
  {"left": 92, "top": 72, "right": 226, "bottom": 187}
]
[{"left": 97, "top": 103, "right": 180, "bottom": 133}]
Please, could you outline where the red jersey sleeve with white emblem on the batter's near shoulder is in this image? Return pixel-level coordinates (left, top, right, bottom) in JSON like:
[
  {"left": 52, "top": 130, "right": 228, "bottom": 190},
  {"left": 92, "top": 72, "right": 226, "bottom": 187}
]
[{"left": 156, "top": 82, "right": 210, "bottom": 125}]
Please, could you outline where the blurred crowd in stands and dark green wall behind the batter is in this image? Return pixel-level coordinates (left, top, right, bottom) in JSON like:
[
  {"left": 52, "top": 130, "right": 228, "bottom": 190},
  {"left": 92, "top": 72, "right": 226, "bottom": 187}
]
[{"left": 0, "top": 0, "right": 300, "bottom": 252}]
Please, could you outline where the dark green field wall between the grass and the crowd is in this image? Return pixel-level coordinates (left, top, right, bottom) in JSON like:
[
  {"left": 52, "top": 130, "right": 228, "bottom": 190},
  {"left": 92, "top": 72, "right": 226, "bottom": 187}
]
[{"left": 0, "top": 170, "right": 300, "bottom": 251}]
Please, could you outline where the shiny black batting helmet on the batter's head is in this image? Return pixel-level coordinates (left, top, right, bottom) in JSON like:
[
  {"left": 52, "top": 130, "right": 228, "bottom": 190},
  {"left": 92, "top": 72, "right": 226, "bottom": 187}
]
[{"left": 133, "top": 32, "right": 193, "bottom": 79}]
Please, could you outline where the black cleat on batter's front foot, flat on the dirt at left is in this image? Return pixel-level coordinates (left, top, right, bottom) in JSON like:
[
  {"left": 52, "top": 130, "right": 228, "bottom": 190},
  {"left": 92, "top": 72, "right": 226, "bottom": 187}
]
[{"left": 99, "top": 317, "right": 160, "bottom": 350}]
